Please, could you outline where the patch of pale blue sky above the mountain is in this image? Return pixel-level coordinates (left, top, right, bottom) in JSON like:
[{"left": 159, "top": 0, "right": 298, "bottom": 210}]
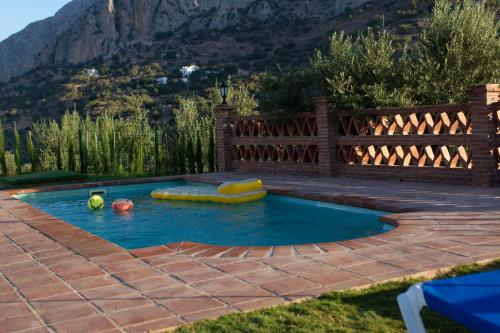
[{"left": 0, "top": 0, "right": 71, "bottom": 41}]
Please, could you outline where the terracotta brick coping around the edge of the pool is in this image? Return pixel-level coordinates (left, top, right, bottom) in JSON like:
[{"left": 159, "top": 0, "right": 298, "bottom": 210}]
[{"left": 0, "top": 175, "right": 410, "bottom": 258}]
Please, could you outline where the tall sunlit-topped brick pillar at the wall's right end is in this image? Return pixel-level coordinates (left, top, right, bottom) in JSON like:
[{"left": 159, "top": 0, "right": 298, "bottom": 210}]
[{"left": 469, "top": 84, "right": 500, "bottom": 186}]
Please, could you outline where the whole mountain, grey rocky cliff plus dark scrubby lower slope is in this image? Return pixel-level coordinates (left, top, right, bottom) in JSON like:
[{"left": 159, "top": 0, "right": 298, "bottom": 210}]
[{"left": 0, "top": 0, "right": 434, "bottom": 129}]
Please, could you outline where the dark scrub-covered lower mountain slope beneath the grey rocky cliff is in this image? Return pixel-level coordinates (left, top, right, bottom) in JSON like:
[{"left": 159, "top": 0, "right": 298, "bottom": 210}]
[{"left": 0, "top": 0, "right": 433, "bottom": 129}]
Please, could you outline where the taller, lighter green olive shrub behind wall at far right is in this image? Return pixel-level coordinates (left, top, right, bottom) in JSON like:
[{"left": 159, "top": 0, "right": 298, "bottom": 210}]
[{"left": 403, "top": 0, "right": 500, "bottom": 104}]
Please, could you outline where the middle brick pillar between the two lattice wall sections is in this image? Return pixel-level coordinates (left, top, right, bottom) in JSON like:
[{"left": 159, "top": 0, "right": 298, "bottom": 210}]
[{"left": 315, "top": 97, "right": 337, "bottom": 177}]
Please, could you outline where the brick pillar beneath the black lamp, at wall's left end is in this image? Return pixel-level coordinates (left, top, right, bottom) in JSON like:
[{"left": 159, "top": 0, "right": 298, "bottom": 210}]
[{"left": 214, "top": 105, "right": 234, "bottom": 172}]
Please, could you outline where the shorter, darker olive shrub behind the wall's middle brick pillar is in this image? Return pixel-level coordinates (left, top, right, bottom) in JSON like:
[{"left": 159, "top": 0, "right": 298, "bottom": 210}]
[{"left": 311, "top": 29, "right": 411, "bottom": 110}]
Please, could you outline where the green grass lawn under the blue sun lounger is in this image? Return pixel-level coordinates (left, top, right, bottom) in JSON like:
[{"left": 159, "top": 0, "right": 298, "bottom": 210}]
[{"left": 176, "top": 260, "right": 500, "bottom": 333}]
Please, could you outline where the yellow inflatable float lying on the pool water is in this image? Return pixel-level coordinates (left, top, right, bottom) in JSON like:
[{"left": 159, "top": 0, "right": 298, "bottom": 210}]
[{"left": 151, "top": 179, "right": 267, "bottom": 204}]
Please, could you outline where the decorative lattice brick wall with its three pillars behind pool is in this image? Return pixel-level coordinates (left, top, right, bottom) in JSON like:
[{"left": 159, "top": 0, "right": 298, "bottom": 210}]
[{"left": 216, "top": 84, "right": 500, "bottom": 186}]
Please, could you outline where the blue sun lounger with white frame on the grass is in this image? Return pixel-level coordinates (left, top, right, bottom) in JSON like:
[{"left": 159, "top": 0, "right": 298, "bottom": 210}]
[{"left": 398, "top": 270, "right": 500, "bottom": 333}]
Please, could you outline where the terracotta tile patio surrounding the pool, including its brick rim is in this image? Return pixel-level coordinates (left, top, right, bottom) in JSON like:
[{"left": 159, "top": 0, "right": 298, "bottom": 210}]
[{"left": 0, "top": 174, "right": 500, "bottom": 333}]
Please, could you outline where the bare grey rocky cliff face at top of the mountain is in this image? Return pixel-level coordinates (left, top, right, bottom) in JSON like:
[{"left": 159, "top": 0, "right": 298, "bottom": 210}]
[{"left": 0, "top": 0, "right": 368, "bottom": 81}]
